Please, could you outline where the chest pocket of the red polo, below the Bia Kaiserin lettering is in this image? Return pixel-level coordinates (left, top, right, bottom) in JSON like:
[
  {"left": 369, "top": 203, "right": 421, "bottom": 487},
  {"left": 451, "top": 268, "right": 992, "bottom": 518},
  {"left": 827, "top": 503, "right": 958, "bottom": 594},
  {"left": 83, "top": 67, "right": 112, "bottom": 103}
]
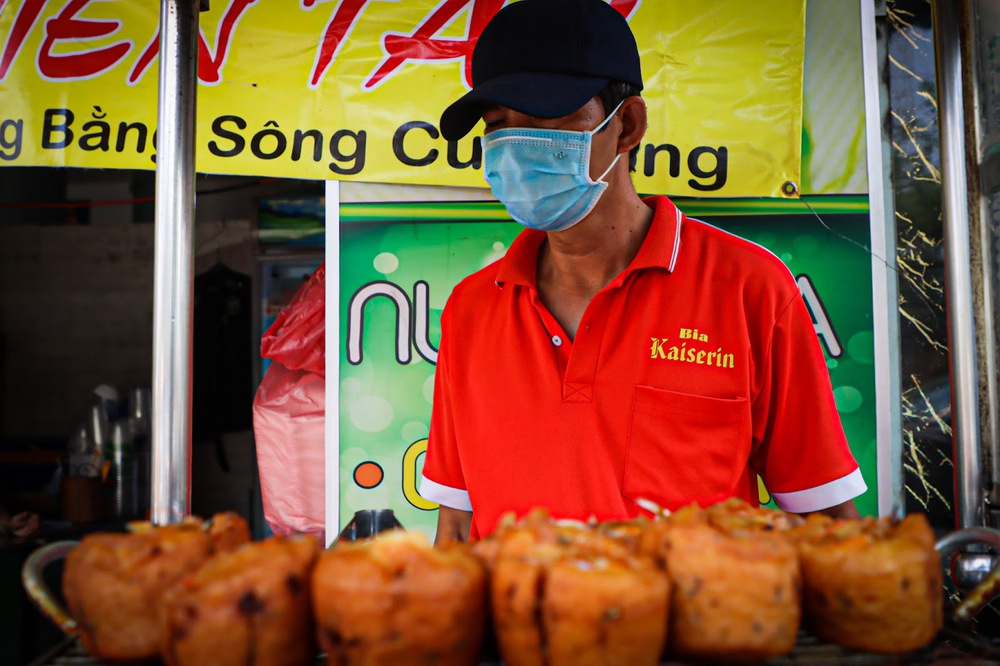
[{"left": 622, "top": 386, "right": 750, "bottom": 510}]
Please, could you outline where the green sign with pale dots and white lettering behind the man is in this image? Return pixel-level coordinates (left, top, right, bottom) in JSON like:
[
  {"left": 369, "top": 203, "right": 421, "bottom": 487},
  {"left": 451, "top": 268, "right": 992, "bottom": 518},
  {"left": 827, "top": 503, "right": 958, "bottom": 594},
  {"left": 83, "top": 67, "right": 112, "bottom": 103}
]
[{"left": 328, "top": 197, "right": 878, "bottom": 535}]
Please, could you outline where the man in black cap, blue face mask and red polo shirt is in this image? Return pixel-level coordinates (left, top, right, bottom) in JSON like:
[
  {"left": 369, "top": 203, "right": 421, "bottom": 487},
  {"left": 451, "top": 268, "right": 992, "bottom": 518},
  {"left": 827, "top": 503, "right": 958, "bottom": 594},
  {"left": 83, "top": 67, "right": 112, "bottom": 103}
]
[{"left": 420, "top": 0, "right": 866, "bottom": 541}]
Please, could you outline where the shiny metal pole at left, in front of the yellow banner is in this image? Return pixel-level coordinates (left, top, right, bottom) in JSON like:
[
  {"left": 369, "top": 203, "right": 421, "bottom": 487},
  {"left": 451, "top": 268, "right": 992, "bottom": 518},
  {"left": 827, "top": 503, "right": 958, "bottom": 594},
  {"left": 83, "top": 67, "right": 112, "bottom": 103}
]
[{"left": 151, "top": 0, "right": 199, "bottom": 525}]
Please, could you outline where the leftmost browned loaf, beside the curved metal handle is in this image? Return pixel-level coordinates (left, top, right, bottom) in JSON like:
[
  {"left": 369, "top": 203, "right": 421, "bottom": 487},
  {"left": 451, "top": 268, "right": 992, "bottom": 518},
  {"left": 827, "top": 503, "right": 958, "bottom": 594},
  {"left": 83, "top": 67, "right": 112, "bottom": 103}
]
[{"left": 63, "top": 522, "right": 213, "bottom": 661}]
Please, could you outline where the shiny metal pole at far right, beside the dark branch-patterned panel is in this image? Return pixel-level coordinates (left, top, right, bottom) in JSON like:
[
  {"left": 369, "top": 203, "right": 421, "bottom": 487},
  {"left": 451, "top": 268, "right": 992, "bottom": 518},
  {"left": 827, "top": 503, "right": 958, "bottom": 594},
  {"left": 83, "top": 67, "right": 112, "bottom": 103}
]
[{"left": 933, "top": 0, "right": 984, "bottom": 527}]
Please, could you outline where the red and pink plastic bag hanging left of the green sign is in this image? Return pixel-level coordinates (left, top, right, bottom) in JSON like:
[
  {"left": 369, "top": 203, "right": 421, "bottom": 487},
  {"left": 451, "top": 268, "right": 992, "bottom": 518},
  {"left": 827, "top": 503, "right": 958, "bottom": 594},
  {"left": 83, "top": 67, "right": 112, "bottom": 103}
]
[{"left": 253, "top": 264, "right": 326, "bottom": 539}]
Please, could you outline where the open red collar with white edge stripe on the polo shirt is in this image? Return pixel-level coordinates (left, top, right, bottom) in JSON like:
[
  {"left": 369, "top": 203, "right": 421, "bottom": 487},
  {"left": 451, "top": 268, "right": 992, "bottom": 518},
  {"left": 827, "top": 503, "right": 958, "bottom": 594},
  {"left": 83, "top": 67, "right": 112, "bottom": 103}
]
[{"left": 495, "top": 191, "right": 684, "bottom": 287}]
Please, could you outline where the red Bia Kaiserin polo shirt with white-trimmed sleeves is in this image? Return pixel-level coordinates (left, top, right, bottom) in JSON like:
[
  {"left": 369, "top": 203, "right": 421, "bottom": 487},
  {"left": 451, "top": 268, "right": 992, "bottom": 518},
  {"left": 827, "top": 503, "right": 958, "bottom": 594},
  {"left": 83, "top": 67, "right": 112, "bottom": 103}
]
[{"left": 420, "top": 197, "right": 866, "bottom": 536}]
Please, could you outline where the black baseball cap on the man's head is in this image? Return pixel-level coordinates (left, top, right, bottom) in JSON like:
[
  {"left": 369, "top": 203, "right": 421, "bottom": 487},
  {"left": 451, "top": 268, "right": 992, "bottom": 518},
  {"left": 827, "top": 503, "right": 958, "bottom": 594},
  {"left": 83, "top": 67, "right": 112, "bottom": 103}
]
[{"left": 441, "top": 0, "right": 642, "bottom": 141}]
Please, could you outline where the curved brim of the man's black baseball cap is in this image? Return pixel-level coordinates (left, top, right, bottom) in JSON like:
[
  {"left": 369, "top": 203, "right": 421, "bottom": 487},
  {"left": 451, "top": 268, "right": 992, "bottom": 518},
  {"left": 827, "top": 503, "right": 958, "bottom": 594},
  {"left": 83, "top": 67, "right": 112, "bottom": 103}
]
[{"left": 441, "top": 72, "right": 608, "bottom": 141}]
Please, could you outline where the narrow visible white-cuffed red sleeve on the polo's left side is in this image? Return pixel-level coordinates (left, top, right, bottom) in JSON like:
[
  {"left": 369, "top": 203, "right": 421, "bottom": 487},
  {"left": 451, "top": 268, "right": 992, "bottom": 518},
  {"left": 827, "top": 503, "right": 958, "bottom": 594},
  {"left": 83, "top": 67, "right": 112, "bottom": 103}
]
[{"left": 420, "top": 306, "right": 472, "bottom": 511}]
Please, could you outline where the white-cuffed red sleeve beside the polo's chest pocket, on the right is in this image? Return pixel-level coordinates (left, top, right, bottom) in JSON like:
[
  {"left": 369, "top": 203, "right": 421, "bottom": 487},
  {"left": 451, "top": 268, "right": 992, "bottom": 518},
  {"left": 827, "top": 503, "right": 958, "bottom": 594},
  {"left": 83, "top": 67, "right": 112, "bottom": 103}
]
[{"left": 750, "top": 293, "right": 867, "bottom": 513}]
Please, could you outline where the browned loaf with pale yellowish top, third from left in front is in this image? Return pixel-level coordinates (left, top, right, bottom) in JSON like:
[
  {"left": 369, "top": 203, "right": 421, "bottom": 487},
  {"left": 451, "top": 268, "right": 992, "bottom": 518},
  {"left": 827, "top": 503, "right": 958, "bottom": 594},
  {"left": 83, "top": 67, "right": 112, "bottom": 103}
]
[{"left": 312, "top": 530, "right": 486, "bottom": 666}]
